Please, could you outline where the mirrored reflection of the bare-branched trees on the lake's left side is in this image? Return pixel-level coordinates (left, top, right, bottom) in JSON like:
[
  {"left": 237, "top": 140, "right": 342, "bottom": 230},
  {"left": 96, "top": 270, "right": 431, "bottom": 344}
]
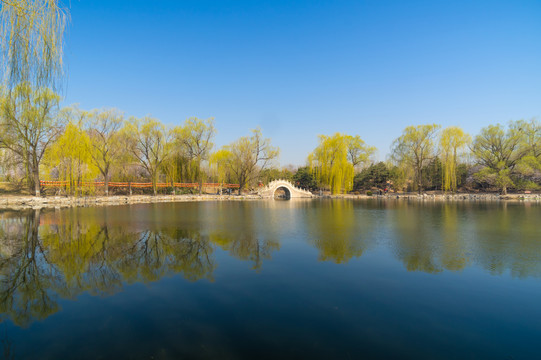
[{"left": 0, "top": 209, "right": 215, "bottom": 325}]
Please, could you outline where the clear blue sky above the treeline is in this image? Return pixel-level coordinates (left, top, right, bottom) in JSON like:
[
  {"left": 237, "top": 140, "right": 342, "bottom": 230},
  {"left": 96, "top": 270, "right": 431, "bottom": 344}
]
[{"left": 64, "top": 0, "right": 541, "bottom": 165}]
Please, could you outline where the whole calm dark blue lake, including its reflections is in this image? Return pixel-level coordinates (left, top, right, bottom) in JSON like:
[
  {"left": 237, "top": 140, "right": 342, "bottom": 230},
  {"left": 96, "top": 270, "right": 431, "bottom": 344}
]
[{"left": 0, "top": 200, "right": 541, "bottom": 359}]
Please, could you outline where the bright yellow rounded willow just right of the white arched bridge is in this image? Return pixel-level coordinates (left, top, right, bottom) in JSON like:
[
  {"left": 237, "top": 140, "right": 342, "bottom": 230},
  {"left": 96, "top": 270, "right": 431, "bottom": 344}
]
[{"left": 308, "top": 133, "right": 375, "bottom": 194}]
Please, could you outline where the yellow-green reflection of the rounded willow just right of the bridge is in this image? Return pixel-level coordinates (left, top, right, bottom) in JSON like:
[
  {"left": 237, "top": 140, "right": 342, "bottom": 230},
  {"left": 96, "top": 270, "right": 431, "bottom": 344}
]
[{"left": 307, "top": 200, "right": 376, "bottom": 264}]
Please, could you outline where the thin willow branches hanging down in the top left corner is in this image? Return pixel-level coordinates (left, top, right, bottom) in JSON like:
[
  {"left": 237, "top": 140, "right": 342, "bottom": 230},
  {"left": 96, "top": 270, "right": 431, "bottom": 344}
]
[{"left": 0, "top": 0, "right": 69, "bottom": 89}]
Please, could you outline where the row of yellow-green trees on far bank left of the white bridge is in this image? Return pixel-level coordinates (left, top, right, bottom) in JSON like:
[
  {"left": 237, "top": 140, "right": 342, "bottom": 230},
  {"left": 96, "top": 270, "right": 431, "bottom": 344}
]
[{"left": 0, "top": 83, "right": 279, "bottom": 195}]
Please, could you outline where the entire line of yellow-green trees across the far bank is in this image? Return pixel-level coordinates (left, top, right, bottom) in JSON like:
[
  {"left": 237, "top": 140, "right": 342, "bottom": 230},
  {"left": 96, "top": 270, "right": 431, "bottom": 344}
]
[{"left": 0, "top": 83, "right": 541, "bottom": 195}]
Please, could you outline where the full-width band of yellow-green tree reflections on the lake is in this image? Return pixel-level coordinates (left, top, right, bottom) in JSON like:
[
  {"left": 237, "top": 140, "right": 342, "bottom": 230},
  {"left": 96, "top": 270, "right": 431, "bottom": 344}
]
[{"left": 0, "top": 201, "right": 541, "bottom": 326}]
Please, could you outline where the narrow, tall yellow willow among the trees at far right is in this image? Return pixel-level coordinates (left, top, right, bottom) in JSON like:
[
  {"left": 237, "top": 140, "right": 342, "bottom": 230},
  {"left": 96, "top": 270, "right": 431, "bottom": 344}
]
[{"left": 439, "top": 126, "right": 471, "bottom": 192}]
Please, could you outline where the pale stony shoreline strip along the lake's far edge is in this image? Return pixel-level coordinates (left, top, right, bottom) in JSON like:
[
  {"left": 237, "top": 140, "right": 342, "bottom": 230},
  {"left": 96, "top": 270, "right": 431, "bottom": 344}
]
[{"left": 0, "top": 193, "right": 541, "bottom": 209}]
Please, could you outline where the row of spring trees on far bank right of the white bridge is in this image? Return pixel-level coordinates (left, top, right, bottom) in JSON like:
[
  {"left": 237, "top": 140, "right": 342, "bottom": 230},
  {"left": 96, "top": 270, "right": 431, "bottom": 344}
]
[{"left": 297, "top": 119, "right": 541, "bottom": 194}]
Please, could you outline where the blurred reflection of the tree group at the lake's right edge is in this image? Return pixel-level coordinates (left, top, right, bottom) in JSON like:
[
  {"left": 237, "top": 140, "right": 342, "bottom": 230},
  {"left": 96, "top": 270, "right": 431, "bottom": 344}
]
[{"left": 390, "top": 203, "right": 541, "bottom": 277}]
